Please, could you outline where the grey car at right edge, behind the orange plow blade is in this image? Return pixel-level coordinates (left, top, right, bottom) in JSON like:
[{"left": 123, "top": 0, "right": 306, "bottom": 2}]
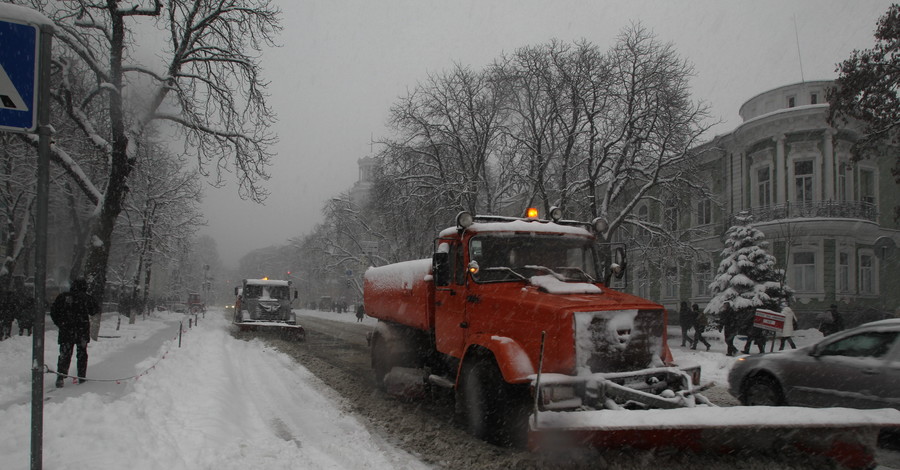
[{"left": 728, "top": 319, "right": 900, "bottom": 409}]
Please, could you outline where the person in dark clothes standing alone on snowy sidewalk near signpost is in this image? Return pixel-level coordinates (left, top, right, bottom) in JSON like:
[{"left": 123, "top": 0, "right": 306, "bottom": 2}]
[{"left": 50, "top": 279, "right": 100, "bottom": 388}]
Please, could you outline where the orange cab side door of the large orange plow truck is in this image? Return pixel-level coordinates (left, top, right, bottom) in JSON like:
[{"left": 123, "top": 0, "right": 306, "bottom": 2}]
[{"left": 434, "top": 239, "right": 468, "bottom": 357}]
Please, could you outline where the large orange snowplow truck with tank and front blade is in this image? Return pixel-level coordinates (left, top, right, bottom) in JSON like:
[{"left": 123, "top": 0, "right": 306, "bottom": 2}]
[{"left": 364, "top": 209, "right": 900, "bottom": 468}]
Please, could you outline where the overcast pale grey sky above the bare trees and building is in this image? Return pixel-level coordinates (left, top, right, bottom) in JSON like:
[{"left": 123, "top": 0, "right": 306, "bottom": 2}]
[{"left": 201, "top": 0, "right": 891, "bottom": 266}]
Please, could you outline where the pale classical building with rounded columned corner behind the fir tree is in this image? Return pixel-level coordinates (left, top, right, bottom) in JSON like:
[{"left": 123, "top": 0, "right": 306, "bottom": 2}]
[{"left": 645, "top": 80, "right": 900, "bottom": 324}]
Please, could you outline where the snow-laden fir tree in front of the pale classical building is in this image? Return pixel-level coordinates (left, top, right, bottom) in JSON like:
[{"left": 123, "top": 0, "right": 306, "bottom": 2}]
[{"left": 705, "top": 212, "right": 794, "bottom": 324}]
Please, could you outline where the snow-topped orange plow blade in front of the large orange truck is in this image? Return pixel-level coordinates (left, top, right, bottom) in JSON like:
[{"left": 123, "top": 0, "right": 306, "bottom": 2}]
[{"left": 528, "top": 406, "right": 900, "bottom": 469}]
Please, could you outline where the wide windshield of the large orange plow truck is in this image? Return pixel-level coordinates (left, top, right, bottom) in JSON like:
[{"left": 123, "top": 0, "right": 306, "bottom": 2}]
[{"left": 469, "top": 233, "right": 598, "bottom": 282}]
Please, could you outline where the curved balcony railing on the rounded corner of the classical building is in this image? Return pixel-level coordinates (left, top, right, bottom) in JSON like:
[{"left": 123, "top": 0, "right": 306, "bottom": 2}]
[{"left": 727, "top": 201, "right": 878, "bottom": 227}]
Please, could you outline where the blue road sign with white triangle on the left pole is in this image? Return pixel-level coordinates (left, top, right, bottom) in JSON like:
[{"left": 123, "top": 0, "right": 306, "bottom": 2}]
[{"left": 0, "top": 19, "right": 41, "bottom": 132}]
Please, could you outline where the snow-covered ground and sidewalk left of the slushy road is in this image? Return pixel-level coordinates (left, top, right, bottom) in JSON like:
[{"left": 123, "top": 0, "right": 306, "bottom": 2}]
[{"left": 0, "top": 311, "right": 427, "bottom": 470}]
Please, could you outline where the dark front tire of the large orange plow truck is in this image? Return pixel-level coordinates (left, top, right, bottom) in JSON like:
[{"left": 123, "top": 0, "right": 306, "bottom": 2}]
[{"left": 458, "top": 359, "right": 528, "bottom": 447}]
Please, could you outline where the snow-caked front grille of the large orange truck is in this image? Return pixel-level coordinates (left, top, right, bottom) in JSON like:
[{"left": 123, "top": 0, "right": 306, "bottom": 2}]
[{"left": 574, "top": 310, "right": 665, "bottom": 375}]
